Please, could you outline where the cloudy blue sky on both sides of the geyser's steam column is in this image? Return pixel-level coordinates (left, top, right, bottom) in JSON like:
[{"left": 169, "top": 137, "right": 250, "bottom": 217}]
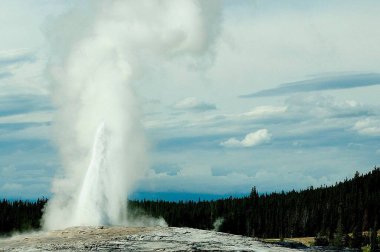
[{"left": 0, "top": 0, "right": 380, "bottom": 199}]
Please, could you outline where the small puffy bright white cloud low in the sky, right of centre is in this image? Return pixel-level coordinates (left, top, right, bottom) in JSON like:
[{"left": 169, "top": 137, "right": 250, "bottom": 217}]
[{"left": 220, "top": 129, "right": 272, "bottom": 147}]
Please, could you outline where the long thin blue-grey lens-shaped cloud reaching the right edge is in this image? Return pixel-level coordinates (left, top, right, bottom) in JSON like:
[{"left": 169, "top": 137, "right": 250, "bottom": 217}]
[{"left": 240, "top": 73, "right": 380, "bottom": 98}]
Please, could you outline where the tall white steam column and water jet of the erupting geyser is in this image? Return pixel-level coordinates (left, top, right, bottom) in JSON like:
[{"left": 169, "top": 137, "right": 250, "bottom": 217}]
[{"left": 43, "top": 0, "right": 221, "bottom": 229}]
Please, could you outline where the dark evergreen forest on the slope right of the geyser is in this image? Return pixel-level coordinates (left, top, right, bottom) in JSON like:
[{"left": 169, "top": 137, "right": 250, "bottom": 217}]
[{"left": 129, "top": 167, "right": 380, "bottom": 240}]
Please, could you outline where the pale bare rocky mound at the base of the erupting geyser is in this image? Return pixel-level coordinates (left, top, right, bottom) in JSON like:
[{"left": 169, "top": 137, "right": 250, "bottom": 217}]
[{"left": 0, "top": 227, "right": 312, "bottom": 252}]
